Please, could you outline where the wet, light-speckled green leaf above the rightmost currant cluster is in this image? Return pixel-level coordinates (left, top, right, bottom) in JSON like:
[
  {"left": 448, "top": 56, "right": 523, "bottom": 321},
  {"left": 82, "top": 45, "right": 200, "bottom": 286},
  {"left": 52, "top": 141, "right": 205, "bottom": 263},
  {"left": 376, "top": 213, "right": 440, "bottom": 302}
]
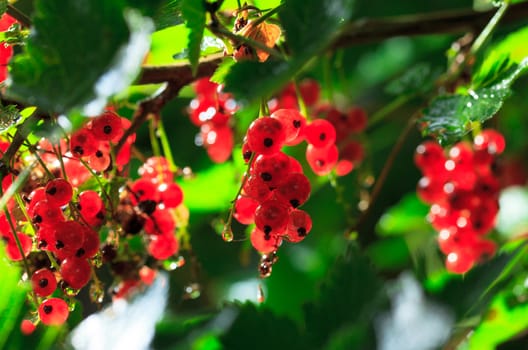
[{"left": 420, "top": 58, "right": 528, "bottom": 142}]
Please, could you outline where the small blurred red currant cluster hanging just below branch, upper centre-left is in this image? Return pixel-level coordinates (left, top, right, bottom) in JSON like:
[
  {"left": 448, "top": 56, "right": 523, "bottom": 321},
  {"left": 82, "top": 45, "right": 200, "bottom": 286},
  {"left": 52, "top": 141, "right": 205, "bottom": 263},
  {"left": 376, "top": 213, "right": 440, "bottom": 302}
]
[{"left": 189, "top": 78, "right": 238, "bottom": 163}]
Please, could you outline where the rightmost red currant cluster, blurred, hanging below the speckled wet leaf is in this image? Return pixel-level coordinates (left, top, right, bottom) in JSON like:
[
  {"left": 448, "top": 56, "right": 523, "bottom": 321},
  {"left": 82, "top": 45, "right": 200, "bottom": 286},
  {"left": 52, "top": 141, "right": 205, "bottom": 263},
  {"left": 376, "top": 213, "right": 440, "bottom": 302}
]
[{"left": 415, "top": 129, "right": 505, "bottom": 274}]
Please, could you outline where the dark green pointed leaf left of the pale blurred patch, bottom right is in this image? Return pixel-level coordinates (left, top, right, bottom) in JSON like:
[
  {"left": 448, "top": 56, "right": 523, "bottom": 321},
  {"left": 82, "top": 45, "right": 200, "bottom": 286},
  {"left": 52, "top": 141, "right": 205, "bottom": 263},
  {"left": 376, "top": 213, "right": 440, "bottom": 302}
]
[{"left": 305, "top": 246, "right": 386, "bottom": 348}]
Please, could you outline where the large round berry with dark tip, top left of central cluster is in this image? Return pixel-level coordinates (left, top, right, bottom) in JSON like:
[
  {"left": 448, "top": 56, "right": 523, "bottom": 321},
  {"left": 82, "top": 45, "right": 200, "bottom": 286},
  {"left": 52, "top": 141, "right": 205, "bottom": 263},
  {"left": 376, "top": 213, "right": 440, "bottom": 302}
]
[{"left": 247, "top": 117, "right": 286, "bottom": 155}]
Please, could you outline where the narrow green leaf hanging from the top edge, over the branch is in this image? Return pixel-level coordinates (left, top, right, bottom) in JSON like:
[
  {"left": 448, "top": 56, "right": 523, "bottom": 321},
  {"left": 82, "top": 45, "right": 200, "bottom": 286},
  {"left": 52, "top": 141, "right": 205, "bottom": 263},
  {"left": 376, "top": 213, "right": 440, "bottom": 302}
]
[{"left": 181, "top": 0, "right": 206, "bottom": 75}]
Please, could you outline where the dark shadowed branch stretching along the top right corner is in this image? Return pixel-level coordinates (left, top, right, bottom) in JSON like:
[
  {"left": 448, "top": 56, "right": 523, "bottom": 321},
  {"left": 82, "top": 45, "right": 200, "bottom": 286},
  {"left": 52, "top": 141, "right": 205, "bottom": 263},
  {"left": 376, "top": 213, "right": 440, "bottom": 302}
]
[{"left": 332, "top": 2, "right": 528, "bottom": 49}]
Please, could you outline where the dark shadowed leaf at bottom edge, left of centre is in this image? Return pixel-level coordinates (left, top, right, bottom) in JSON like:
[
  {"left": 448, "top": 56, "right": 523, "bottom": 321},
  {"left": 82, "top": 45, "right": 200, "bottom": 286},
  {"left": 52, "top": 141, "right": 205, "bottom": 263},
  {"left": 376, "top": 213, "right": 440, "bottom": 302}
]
[{"left": 220, "top": 302, "right": 306, "bottom": 350}]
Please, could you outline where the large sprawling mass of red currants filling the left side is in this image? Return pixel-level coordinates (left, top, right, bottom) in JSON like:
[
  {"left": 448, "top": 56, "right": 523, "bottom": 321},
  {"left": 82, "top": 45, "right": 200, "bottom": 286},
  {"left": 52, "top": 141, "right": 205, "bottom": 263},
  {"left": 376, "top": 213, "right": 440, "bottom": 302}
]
[{"left": 0, "top": 110, "right": 186, "bottom": 334}]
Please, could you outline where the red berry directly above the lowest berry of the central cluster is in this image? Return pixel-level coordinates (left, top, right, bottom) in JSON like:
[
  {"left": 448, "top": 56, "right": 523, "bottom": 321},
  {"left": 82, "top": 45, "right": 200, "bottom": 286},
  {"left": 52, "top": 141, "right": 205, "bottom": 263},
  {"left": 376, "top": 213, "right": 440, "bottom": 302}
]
[{"left": 255, "top": 199, "right": 289, "bottom": 235}]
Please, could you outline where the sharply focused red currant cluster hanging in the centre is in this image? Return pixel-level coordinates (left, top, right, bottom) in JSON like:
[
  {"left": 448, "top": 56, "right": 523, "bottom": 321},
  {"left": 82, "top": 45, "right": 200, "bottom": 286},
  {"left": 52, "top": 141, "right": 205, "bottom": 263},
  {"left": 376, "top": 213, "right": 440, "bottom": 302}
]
[{"left": 234, "top": 109, "right": 312, "bottom": 260}]
